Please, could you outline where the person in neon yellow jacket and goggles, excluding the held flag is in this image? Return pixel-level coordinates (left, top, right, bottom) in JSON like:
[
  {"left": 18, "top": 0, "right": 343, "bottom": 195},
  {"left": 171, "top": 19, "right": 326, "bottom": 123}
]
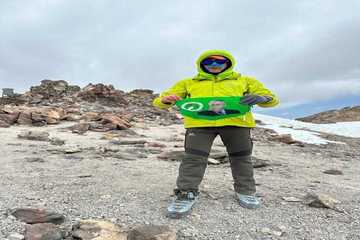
[{"left": 153, "top": 50, "right": 279, "bottom": 218}]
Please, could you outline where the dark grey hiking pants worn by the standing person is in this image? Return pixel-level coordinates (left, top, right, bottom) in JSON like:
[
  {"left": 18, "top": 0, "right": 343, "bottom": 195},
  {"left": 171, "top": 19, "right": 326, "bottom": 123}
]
[{"left": 176, "top": 126, "right": 256, "bottom": 195}]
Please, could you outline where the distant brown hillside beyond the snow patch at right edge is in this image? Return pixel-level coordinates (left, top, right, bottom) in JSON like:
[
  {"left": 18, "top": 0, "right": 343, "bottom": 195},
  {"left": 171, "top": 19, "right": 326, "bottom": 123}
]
[{"left": 297, "top": 106, "right": 360, "bottom": 123}]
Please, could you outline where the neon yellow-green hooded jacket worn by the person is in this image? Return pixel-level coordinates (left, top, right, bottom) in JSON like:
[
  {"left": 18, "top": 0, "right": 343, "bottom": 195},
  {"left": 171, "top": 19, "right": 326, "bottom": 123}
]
[{"left": 153, "top": 50, "right": 279, "bottom": 128}]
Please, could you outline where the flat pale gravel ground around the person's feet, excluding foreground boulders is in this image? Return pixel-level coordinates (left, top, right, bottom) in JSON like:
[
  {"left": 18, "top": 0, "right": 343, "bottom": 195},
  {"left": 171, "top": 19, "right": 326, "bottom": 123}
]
[{"left": 0, "top": 123, "right": 360, "bottom": 239}]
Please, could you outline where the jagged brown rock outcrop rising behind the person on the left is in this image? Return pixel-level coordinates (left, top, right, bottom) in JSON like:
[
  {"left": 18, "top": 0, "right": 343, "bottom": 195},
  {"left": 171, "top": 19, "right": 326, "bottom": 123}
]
[{"left": 0, "top": 80, "right": 179, "bottom": 131}]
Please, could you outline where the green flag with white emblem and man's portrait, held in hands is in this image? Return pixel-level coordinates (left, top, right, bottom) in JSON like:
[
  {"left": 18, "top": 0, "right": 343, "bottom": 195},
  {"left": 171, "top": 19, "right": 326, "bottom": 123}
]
[{"left": 176, "top": 97, "right": 251, "bottom": 120}]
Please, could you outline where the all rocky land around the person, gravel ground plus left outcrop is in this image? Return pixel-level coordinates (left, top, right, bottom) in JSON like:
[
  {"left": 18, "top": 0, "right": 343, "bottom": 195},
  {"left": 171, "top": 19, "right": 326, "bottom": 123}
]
[{"left": 0, "top": 80, "right": 360, "bottom": 240}]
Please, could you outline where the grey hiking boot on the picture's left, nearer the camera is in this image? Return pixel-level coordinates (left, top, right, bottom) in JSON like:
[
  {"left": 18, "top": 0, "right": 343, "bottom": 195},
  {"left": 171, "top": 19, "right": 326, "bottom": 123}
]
[{"left": 167, "top": 190, "right": 198, "bottom": 218}]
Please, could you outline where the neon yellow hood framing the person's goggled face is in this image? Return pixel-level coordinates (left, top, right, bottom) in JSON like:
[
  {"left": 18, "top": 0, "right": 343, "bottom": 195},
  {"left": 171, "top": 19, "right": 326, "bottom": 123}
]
[{"left": 194, "top": 50, "right": 237, "bottom": 80}]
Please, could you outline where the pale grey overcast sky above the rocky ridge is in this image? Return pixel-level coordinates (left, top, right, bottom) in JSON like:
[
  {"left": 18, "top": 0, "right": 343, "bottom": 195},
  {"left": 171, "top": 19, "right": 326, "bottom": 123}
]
[{"left": 0, "top": 0, "right": 360, "bottom": 107}]
